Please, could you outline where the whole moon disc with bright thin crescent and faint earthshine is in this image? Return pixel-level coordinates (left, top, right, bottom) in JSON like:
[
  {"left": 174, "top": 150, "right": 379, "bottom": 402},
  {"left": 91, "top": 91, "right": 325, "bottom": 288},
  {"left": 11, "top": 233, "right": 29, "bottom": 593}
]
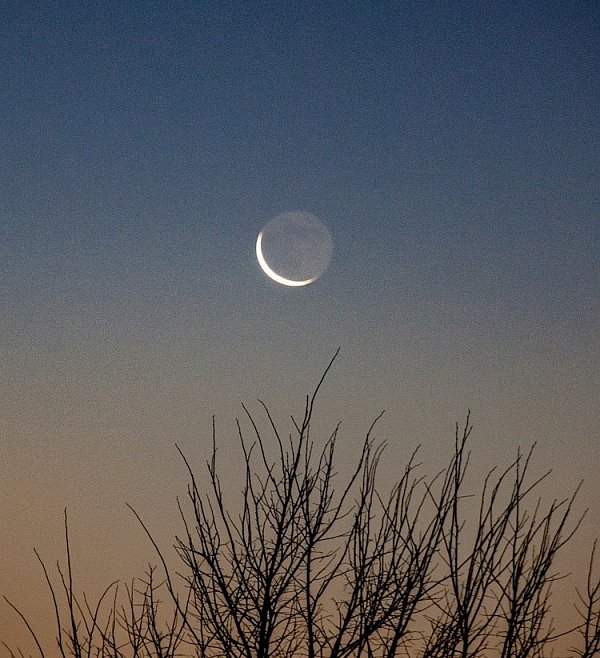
[{"left": 256, "top": 211, "right": 333, "bottom": 287}]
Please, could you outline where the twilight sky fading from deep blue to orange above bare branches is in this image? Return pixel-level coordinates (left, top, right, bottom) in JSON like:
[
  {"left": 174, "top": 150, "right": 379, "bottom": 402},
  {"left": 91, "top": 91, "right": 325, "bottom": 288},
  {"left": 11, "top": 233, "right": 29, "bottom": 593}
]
[{"left": 0, "top": 0, "right": 600, "bottom": 650}]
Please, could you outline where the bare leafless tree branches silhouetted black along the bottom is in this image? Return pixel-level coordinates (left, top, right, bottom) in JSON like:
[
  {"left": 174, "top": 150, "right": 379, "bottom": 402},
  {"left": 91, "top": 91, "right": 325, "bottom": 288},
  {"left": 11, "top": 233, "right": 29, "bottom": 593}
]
[{"left": 8, "top": 357, "right": 600, "bottom": 658}]
